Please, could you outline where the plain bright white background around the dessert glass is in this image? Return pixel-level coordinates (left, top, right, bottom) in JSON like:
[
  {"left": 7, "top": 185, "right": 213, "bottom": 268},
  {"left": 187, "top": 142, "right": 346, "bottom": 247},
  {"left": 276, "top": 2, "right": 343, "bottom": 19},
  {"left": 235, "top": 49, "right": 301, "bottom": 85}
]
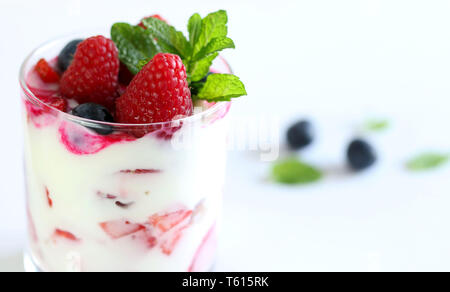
[{"left": 0, "top": 0, "right": 450, "bottom": 271}]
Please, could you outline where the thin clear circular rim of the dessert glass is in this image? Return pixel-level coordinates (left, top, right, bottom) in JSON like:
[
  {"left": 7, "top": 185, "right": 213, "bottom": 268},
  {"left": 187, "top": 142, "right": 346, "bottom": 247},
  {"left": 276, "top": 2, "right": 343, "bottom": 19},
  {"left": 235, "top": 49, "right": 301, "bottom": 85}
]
[{"left": 19, "top": 33, "right": 232, "bottom": 128}]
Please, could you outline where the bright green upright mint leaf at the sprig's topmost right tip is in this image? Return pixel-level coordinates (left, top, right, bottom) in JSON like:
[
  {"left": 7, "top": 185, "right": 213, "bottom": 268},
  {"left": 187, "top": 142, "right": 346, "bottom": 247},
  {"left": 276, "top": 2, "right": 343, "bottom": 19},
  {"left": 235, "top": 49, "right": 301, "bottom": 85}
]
[{"left": 194, "top": 10, "right": 228, "bottom": 55}]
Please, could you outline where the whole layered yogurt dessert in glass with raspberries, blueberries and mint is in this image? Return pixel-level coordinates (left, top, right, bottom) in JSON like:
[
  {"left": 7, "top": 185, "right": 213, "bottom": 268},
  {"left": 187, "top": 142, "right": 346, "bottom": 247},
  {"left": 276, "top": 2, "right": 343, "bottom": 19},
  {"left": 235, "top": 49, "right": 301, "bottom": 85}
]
[{"left": 21, "top": 11, "right": 246, "bottom": 272}]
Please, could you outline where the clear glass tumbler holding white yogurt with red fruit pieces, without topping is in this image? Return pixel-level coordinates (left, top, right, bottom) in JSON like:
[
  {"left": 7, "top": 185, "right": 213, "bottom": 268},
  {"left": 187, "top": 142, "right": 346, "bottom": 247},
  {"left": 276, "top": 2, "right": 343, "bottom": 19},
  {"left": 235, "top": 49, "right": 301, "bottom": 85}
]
[{"left": 20, "top": 35, "right": 231, "bottom": 272}]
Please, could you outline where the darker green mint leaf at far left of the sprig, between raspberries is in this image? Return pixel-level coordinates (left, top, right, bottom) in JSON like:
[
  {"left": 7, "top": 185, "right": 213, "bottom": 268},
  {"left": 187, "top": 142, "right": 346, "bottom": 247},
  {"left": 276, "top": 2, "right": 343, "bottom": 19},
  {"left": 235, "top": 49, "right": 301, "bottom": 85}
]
[{"left": 111, "top": 23, "right": 159, "bottom": 74}]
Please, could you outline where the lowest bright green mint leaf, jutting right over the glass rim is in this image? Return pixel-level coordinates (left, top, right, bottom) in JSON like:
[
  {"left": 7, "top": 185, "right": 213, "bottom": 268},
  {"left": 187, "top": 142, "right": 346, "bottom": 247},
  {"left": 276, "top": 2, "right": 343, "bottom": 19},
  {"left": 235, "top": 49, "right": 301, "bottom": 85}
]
[{"left": 197, "top": 74, "right": 247, "bottom": 101}]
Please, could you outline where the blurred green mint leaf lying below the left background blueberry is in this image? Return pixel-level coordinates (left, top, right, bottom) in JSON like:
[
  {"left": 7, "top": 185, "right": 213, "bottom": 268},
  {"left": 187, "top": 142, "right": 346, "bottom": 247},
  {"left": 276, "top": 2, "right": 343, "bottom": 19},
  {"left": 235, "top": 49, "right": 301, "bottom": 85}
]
[{"left": 272, "top": 158, "right": 323, "bottom": 184}]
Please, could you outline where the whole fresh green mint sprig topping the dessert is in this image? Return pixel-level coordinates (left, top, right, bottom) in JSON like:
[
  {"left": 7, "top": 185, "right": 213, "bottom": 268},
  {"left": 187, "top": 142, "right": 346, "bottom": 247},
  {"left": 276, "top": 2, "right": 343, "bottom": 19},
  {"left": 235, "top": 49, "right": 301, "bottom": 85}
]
[{"left": 111, "top": 10, "right": 247, "bottom": 102}]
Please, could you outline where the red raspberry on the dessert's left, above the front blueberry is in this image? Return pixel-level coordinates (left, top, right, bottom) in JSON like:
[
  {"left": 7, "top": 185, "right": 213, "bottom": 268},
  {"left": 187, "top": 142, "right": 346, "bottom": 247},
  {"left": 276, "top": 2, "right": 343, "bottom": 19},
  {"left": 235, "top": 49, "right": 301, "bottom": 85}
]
[{"left": 61, "top": 36, "right": 120, "bottom": 109}]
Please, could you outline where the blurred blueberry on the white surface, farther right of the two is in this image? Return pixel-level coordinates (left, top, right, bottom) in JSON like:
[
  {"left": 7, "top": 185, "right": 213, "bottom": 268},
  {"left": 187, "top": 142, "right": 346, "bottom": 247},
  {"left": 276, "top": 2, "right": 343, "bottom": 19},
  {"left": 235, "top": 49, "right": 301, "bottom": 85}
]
[{"left": 347, "top": 139, "right": 377, "bottom": 171}]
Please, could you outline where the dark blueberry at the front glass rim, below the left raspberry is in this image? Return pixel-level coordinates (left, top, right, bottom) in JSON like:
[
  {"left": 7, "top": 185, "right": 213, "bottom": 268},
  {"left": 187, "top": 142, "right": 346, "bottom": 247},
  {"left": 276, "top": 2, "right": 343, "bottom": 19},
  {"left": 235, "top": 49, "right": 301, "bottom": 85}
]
[{"left": 72, "top": 103, "right": 114, "bottom": 135}]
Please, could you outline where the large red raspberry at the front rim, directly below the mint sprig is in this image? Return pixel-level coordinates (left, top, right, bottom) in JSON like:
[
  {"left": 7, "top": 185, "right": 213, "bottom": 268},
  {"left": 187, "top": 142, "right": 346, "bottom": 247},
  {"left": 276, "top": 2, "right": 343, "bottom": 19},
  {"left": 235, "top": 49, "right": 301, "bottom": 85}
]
[{"left": 116, "top": 53, "right": 193, "bottom": 130}]
